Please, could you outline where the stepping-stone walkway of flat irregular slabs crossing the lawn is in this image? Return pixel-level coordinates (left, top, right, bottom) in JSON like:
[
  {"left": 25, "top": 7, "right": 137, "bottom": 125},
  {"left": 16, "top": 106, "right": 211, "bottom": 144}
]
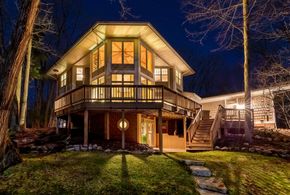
[{"left": 181, "top": 159, "right": 228, "bottom": 195}]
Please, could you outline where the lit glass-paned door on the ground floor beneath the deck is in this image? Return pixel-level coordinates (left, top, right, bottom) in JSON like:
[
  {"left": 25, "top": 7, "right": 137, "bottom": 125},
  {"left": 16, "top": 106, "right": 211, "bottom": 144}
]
[{"left": 141, "top": 118, "right": 154, "bottom": 146}]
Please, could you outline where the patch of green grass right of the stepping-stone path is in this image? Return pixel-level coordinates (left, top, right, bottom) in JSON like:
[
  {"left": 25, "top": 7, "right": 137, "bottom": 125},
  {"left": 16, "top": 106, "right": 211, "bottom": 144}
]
[{"left": 170, "top": 151, "right": 290, "bottom": 195}]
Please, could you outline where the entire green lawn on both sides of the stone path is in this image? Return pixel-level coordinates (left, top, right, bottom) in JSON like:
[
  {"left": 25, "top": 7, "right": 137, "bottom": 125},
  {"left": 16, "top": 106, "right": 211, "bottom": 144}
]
[{"left": 0, "top": 151, "right": 290, "bottom": 195}]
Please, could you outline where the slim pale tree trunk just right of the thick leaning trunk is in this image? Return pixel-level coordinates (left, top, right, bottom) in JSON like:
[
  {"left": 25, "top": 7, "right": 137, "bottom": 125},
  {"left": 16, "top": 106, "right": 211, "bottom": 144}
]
[{"left": 19, "top": 37, "right": 32, "bottom": 129}]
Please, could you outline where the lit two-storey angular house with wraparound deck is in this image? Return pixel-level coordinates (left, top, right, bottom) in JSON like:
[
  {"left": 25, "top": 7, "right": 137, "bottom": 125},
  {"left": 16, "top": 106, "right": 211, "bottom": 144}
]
[{"left": 47, "top": 22, "right": 201, "bottom": 151}]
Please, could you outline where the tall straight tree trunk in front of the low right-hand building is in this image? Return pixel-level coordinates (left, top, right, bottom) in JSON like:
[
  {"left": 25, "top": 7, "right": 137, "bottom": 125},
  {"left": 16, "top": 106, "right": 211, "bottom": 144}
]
[{"left": 242, "top": 0, "right": 253, "bottom": 143}]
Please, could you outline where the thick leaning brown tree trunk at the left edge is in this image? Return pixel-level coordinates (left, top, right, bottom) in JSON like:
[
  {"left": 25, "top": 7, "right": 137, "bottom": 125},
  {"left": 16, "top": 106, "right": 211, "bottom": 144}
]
[{"left": 0, "top": 0, "right": 40, "bottom": 172}]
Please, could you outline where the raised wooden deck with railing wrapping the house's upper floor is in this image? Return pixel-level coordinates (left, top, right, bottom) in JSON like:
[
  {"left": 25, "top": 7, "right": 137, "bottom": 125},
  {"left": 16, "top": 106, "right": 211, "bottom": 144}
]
[{"left": 54, "top": 85, "right": 201, "bottom": 117}]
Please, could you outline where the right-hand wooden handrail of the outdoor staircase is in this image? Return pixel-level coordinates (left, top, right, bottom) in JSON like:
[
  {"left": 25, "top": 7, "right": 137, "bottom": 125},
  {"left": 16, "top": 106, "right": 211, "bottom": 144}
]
[{"left": 210, "top": 105, "right": 225, "bottom": 148}]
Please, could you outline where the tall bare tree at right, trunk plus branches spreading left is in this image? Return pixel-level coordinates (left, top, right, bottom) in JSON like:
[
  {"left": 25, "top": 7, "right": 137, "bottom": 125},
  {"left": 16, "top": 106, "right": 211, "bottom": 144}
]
[{"left": 184, "top": 0, "right": 253, "bottom": 142}]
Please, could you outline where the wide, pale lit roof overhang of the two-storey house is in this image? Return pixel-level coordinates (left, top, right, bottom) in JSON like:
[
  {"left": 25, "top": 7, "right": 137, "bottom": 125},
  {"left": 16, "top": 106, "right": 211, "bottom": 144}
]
[{"left": 47, "top": 22, "right": 195, "bottom": 77}]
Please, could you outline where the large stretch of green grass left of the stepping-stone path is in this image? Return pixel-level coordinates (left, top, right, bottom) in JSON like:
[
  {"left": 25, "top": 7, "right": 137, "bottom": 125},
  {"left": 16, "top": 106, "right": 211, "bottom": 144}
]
[{"left": 0, "top": 152, "right": 195, "bottom": 194}]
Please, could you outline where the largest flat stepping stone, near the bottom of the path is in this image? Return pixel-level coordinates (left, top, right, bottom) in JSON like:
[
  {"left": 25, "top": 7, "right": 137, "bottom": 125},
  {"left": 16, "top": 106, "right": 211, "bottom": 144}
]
[{"left": 194, "top": 177, "right": 228, "bottom": 194}]
